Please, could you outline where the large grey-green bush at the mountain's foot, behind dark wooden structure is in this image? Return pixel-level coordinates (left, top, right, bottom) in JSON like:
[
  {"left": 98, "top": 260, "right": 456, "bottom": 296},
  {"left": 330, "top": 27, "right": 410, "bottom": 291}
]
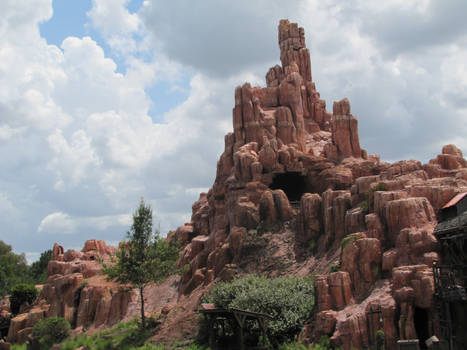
[{"left": 203, "top": 275, "right": 314, "bottom": 344}]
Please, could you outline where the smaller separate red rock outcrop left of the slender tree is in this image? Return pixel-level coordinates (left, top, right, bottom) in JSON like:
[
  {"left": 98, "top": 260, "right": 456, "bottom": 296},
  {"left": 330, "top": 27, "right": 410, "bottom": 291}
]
[{"left": 8, "top": 240, "right": 143, "bottom": 343}]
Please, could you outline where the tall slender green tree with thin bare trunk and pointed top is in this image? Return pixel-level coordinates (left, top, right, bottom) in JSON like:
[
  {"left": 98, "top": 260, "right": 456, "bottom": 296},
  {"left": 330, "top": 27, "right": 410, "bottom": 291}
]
[{"left": 103, "top": 199, "right": 179, "bottom": 328}]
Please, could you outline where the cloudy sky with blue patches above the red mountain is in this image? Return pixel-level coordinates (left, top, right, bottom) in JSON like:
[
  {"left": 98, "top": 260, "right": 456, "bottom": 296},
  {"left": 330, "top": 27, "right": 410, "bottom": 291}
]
[{"left": 0, "top": 0, "right": 467, "bottom": 261}]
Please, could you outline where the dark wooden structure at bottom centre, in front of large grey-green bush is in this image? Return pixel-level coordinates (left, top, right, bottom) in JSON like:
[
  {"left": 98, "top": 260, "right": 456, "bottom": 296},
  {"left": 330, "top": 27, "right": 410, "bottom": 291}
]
[{"left": 199, "top": 304, "right": 273, "bottom": 350}]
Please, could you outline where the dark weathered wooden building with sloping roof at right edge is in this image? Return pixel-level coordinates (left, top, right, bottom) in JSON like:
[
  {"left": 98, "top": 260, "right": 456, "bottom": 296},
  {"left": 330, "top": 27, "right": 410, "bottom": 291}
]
[{"left": 433, "top": 192, "right": 467, "bottom": 350}]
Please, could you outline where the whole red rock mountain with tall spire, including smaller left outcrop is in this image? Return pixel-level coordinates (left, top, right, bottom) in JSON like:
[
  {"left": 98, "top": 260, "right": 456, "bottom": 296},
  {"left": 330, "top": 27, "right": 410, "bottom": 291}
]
[{"left": 9, "top": 20, "right": 467, "bottom": 349}]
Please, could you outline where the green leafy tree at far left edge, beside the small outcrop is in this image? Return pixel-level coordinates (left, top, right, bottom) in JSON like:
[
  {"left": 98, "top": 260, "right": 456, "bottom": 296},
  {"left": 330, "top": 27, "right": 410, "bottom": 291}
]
[{"left": 0, "top": 241, "right": 31, "bottom": 296}]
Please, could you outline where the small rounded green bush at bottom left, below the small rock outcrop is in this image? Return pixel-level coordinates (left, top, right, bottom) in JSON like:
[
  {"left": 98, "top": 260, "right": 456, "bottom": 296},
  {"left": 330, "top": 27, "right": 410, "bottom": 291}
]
[{"left": 32, "top": 317, "right": 71, "bottom": 349}]
